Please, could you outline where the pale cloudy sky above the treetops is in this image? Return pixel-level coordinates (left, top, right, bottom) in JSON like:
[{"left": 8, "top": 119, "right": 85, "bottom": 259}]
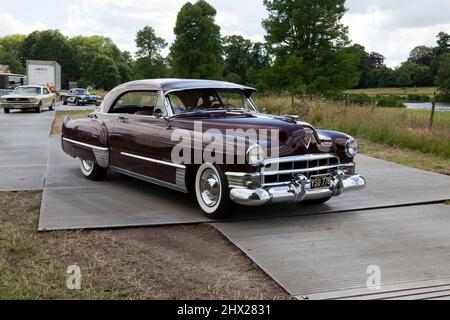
[{"left": 0, "top": 0, "right": 450, "bottom": 67}]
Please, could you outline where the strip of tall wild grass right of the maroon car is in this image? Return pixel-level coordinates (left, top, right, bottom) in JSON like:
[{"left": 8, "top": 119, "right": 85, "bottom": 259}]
[{"left": 255, "top": 97, "right": 450, "bottom": 159}]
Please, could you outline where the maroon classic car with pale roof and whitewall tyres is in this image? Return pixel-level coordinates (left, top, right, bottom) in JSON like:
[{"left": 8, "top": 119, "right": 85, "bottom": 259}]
[{"left": 61, "top": 79, "right": 366, "bottom": 219}]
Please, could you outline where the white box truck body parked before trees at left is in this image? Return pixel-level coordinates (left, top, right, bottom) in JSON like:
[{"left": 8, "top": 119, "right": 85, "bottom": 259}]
[{"left": 27, "top": 60, "right": 61, "bottom": 91}]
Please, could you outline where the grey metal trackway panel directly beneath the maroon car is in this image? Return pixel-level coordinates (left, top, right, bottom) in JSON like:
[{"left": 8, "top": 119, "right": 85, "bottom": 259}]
[{"left": 39, "top": 139, "right": 450, "bottom": 230}]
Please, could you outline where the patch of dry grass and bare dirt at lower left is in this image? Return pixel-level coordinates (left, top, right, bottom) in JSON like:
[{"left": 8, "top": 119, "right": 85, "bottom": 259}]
[{"left": 0, "top": 192, "right": 290, "bottom": 299}]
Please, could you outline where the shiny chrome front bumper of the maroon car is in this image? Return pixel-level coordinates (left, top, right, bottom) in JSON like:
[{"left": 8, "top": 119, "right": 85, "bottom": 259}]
[{"left": 230, "top": 171, "right": 366, "bottom": 206}]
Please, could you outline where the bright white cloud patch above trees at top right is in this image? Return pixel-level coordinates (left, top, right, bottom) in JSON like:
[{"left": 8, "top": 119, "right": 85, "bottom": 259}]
[{"left": 343, "top": 0, "right": 450, "bottom": 67}]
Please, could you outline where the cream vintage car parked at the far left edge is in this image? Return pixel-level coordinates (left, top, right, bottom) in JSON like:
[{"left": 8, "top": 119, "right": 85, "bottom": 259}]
[{"left": 0, "top": 86, "right": 56, "bottom": 113}]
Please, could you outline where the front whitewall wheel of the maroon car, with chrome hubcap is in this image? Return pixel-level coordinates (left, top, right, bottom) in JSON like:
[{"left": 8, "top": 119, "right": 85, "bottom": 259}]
[{"left": 195, "top": 163, "right": 234, "bottom": 220}]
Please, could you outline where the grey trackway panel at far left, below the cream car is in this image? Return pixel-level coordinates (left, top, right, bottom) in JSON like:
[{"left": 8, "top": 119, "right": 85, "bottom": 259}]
[{"left": 0, "top": 111, "right": 55, "bottom": 191}]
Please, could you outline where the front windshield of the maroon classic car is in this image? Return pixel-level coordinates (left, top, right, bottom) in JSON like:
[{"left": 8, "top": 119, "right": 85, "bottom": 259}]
[{"left": 168, "top": 89, "right": 257, "bottom": 115}]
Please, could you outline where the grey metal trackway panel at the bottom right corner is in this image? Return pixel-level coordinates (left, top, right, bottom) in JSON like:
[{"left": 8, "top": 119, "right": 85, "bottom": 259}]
[{"left": 213, "top": 204, "right": 450, "bottom": 299}]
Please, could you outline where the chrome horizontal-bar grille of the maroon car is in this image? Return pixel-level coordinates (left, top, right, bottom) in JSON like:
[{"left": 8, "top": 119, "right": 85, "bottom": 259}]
[{"left": 261, "top": 154, "right": 340, "bottom": 186}]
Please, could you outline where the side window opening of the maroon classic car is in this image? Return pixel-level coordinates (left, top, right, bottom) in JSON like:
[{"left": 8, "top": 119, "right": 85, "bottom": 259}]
[{"left": 109, "top": 91, "right": 158, "bottom": 116}]
